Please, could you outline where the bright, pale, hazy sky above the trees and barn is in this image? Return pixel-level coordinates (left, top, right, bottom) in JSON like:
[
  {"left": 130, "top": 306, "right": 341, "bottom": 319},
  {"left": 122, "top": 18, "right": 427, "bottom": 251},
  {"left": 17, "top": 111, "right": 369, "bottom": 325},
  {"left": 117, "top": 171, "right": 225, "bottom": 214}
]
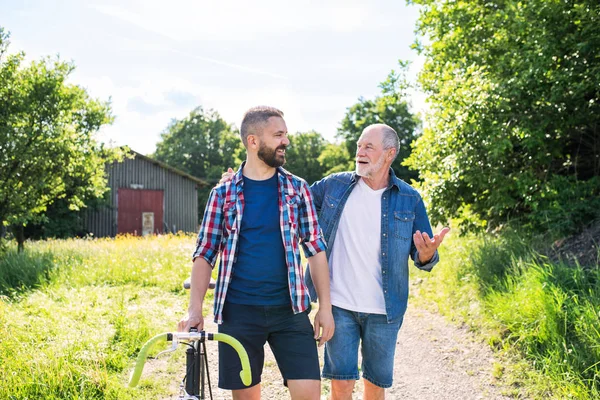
[{"left": 0, "top": 0, "right": 426, "bottom": 154}]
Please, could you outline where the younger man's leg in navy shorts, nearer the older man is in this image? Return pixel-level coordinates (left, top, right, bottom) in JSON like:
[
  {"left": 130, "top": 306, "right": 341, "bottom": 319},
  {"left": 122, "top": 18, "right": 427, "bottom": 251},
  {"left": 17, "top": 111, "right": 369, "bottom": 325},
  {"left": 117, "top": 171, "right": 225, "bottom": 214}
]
[{"left": 268, "top": 306, "right": 321, "bottom": 400}]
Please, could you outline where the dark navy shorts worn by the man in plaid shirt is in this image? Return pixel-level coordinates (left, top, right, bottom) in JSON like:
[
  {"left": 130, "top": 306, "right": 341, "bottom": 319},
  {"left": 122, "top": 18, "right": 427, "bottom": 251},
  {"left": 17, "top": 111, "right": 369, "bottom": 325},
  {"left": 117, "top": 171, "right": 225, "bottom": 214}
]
[{"left": 219, "top": 302, "right": 320, "bottom": 390}]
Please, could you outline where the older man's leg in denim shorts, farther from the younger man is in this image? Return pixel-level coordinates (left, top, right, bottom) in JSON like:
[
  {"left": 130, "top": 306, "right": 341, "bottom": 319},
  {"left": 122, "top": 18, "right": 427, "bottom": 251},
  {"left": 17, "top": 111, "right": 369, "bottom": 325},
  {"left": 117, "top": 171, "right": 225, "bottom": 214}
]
[{"left": 361, "top": 314, "right": 402, "bottom": 400}]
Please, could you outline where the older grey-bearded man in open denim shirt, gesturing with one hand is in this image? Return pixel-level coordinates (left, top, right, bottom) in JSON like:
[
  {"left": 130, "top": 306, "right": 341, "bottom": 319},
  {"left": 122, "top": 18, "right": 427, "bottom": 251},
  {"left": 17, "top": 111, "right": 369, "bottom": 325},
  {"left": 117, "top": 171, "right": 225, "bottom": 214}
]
[{"left": 307, "top": 124, "right": 449, "bottom": 400}]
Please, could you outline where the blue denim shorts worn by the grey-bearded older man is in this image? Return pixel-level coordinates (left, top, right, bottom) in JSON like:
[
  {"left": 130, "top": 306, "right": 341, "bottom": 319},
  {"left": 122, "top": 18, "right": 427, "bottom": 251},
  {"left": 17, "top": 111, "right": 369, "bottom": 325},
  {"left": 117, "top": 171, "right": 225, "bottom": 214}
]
[{"left": 322, "top": 306, "right": 402, "bottom": 388}]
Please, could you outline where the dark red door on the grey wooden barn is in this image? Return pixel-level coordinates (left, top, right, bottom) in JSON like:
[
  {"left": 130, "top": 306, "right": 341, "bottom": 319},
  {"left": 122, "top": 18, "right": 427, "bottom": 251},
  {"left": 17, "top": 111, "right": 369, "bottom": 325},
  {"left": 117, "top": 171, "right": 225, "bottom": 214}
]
[{"left": 117, "top": 188, "right": 164, "bottom": 236}]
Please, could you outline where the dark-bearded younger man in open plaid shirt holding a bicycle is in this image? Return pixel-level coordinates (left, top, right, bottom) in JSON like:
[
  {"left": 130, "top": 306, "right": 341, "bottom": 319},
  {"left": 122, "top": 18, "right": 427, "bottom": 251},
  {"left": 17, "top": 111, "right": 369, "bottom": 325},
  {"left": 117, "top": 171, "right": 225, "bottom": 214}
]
[{"left": 178, "top": 107, "right": 334, "bottom": 400}]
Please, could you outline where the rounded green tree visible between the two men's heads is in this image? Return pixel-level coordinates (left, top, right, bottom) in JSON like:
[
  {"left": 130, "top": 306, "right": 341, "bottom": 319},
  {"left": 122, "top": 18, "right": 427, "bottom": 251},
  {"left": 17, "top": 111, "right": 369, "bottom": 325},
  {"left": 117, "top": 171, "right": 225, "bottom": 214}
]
[{"left": 284, "top": 131, "right": 326, "bottom": 184}]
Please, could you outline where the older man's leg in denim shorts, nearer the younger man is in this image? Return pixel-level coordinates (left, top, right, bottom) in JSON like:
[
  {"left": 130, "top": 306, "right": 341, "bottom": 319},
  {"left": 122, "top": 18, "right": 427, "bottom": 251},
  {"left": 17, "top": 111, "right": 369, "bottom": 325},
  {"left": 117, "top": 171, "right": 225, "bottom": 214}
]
[{"left": 323, "top": 306, "right": 361, "bottom": 400}]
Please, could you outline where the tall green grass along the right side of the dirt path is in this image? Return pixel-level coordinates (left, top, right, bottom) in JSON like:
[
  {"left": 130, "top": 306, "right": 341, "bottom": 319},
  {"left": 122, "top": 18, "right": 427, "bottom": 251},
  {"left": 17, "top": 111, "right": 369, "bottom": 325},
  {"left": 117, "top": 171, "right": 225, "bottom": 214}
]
[{"left": 413, "top": 230, "right": 600, "bottom": 399}]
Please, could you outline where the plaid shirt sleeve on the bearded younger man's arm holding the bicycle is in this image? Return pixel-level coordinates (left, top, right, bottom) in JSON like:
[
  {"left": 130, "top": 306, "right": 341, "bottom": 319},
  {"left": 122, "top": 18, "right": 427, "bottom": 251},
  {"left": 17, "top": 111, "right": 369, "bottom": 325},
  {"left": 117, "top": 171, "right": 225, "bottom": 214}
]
[{"left": 192, "top": 189, "right": 223, "bottom": 268}]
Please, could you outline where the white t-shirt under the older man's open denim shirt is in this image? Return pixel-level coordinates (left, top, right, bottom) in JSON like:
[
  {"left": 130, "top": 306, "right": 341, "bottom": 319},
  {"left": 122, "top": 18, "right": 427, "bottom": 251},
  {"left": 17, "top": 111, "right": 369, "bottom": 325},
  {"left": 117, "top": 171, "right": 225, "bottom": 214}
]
[{"left": 329, "top": 179, "right": 386, "bottom": 314}]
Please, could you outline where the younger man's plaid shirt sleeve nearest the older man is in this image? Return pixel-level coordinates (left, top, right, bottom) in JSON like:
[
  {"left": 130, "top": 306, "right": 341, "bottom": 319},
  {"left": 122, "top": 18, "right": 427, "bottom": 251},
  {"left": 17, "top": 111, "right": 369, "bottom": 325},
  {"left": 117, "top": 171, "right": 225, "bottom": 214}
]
[{"left": 298, "top": 181, "right": 327, "bottom": 258}]
